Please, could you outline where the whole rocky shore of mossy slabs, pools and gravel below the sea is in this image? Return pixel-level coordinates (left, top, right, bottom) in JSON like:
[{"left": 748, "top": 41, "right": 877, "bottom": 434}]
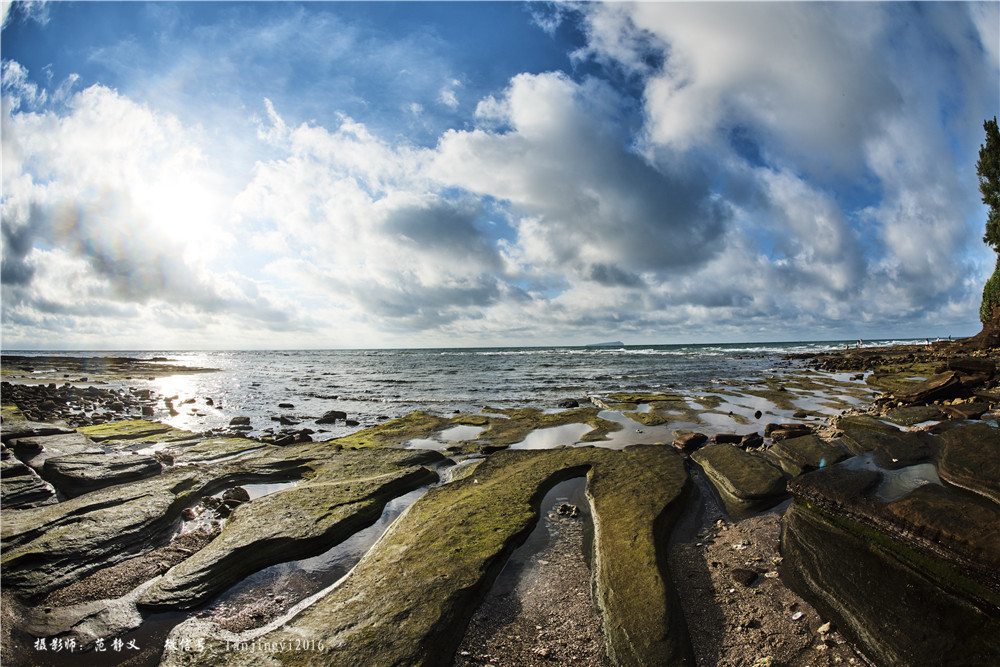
[{"left": 0, "top": 342, "right": 1000, "bottom": 667}]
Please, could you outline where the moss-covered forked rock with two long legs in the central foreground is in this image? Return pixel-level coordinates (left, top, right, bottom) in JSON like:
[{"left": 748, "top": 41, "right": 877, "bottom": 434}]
[{"left": 161, "top": 447, "right": 693, "bottom": 665}]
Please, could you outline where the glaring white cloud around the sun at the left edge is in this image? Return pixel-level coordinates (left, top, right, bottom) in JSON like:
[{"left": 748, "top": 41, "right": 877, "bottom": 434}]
[{"left": 3, "top": 73, "right": 288, "bottom": 348}]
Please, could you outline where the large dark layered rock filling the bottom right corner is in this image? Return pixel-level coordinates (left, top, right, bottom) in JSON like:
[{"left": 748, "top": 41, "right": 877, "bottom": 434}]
[{"left": 781, "top": 436, "right": 1000, "bottom": 665}]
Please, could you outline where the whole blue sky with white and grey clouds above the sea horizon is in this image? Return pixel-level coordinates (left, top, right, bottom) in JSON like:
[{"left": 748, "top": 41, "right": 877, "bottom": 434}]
[{"left": 0, "top": 1, "right": 1000, "bottom": 350}]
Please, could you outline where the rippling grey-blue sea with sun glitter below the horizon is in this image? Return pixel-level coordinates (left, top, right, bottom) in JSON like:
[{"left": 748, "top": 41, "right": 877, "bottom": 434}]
[{"left": 7, "top": 340, "right": 923, "bottom": 439}]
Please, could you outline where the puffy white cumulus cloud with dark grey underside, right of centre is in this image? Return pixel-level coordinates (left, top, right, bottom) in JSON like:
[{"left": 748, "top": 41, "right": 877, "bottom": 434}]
[{"left": 434, "top": 73, "right": 727, "bottom": 284}]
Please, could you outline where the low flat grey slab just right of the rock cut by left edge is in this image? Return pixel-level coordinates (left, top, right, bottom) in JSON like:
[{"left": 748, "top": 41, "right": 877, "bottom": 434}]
[{"left": 42, "top": 453, "right": 163, "bottom": 498}]
